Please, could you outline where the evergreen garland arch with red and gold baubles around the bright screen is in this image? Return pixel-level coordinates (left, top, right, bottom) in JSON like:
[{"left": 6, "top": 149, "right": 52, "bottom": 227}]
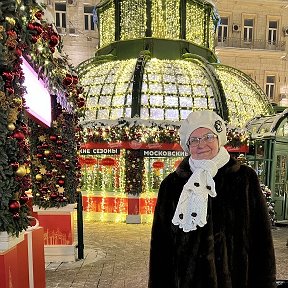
[{"left": 0, "top": 0, "right": 85, "bottom": 236}]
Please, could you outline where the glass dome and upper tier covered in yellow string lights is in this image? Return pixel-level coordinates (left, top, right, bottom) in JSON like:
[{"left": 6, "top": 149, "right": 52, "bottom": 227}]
[{"left": 78, "top": 0, "right": 273, "bottom": 127}]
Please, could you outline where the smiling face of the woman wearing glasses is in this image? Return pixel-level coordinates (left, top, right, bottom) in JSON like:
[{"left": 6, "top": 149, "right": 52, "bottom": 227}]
[{"left": 188, "top": 127, "right": 219, "bottom": 160}]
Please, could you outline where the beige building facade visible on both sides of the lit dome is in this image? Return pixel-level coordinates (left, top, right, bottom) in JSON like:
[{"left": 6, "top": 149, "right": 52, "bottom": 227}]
[{"left": 45, "top": 0, "right": 288, "bottom": 107}]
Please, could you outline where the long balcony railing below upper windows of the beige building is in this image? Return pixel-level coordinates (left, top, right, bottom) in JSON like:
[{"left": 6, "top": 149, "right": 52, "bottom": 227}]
[{"left": 216, "top": 37, "right": 285, "bottom": 51}]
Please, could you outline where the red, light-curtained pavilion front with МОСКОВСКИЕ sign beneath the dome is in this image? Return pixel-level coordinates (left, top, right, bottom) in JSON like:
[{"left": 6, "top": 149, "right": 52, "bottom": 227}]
[{"left": 80, "top": 141, "right": 185, "bottom": 223}]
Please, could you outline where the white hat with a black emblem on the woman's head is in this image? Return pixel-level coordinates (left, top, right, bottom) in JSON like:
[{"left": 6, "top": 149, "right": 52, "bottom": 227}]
[{"left": 179, "top": 110, "right": 227, "bottom": 154}]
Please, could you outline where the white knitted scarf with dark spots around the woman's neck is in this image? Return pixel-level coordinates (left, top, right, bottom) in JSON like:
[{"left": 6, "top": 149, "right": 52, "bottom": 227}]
[{"left": 172, "top": 147, "right": 230, "bottom": 232}]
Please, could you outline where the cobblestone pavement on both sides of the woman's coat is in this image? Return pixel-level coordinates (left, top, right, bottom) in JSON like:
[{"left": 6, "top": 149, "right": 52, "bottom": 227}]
[{"left": 46, "top": 220, "right": 288, "bottom": 288}]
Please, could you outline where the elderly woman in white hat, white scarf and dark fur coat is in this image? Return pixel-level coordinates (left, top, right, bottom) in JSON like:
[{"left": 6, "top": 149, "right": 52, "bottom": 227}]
[{"left": 149, "top": 111, "right": 276, "bottom": 288}]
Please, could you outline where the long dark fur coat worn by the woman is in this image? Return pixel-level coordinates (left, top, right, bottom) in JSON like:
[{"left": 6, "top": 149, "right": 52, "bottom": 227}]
[{"left": 149, "top": 157, "right": 276, "bottom": 288}]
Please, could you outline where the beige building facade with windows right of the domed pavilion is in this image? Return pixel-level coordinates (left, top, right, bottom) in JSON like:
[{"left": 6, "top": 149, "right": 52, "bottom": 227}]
[{"left": 215, "top": 0, "right": 288, "bottom": 106}]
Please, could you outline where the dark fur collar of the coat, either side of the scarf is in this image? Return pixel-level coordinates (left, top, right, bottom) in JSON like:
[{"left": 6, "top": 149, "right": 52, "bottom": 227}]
[{"left": 176, "top": 156, "right": 241, "bottom": 178}]
